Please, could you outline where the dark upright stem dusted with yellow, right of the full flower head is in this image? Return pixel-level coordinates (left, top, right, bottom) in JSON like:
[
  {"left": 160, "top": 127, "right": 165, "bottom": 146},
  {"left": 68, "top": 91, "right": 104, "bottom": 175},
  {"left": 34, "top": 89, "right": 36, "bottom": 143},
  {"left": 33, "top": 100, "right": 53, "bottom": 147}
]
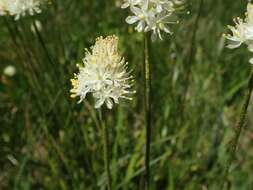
[{"left": 143, "top": 33, "right": 151, "bottom": 190}]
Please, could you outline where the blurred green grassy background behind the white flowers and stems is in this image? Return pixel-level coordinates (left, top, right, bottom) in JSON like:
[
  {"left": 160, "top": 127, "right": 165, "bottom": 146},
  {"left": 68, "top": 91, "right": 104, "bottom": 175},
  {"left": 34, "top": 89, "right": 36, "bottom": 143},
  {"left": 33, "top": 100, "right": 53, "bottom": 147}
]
[{"left": 0, "top": 0, "right": 253, "bottom": 190}]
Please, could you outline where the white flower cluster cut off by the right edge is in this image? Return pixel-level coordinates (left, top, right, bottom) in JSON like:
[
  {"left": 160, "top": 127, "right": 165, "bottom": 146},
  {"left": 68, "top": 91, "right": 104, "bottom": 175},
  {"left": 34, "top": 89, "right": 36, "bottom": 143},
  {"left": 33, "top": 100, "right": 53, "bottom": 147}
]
[{"left": 225, "top": 3, "right": 253, "bottom": 64}]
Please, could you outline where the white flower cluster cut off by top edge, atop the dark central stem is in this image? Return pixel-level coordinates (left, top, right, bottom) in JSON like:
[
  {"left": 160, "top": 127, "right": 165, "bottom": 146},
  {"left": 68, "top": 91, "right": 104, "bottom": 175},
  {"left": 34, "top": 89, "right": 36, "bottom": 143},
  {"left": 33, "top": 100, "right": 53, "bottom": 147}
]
[{"left": 121, "top": 0, "right": 180, "bottom": 41}]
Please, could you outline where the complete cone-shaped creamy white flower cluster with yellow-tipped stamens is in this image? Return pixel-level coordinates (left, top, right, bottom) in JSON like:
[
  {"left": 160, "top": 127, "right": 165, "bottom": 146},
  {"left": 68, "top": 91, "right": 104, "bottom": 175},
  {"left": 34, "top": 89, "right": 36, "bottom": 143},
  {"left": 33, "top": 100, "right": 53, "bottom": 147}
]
[{"left": 70, "top": 36, "right": 134, "bottom": 109}]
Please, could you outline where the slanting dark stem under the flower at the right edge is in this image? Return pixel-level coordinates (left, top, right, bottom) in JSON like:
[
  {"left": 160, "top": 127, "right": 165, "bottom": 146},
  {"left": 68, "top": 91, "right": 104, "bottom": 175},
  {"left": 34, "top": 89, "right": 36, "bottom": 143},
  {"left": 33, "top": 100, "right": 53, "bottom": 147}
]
[{"left": 221, "top": 71, "right": 253, "bottom": 189}]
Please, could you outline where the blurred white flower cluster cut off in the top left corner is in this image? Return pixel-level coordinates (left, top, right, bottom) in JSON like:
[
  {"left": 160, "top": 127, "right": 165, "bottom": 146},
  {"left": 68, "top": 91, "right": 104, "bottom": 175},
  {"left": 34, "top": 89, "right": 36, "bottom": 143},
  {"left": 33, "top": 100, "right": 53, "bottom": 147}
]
[{"left": 0, "top": 0, "right": 43, "bottom": 20}]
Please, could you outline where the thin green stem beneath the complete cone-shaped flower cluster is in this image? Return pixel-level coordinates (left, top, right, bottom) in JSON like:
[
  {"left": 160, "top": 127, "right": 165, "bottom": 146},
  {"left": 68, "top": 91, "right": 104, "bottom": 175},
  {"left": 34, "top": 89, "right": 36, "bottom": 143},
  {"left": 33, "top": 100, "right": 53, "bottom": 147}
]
[{"left": 98, "top": 109, "right": 112, "bottom": 190}]
